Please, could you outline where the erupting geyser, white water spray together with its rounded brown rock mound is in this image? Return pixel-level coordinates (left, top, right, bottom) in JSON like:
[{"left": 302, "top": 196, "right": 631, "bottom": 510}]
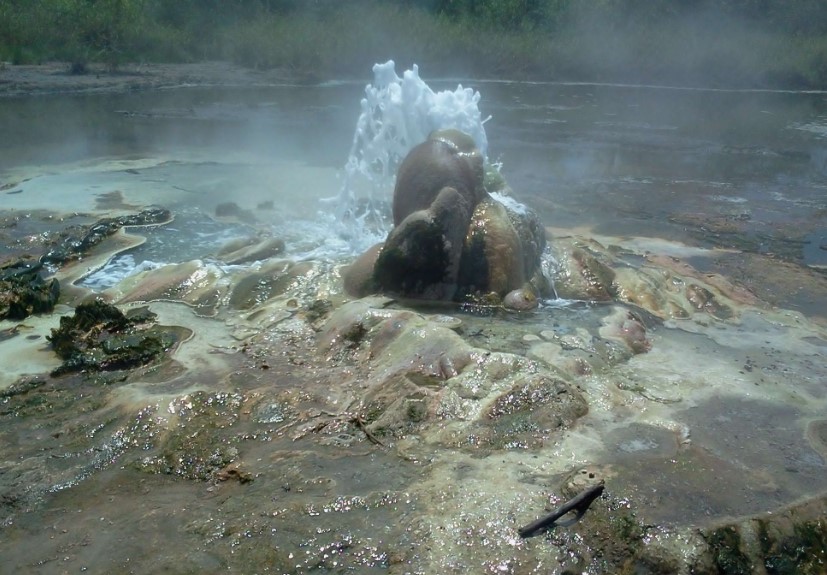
[{"left": 339, "top": 61, "right": 549, "bottom": 309}]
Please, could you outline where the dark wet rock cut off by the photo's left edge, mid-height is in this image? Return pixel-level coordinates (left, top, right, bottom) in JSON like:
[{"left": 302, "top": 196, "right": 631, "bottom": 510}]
[{"left": 0, "top": 260, "right": 60, "bottom": 320}]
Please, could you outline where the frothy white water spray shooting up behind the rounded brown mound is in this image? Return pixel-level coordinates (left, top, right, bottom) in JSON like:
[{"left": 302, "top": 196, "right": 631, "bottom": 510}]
[{"left": 331, "top": 60, "right": 488, "bottom": 248}]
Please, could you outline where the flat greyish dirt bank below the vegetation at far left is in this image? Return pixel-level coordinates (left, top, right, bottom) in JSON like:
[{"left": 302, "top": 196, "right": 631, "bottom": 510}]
[{"left": 0, "top": 62, "right": 307, "bottom": 97}]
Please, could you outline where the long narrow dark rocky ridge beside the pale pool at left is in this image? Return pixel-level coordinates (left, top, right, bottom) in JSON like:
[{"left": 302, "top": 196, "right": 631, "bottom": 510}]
[{"left": 40, "top": 207, "right": 171, "bottom": 266}]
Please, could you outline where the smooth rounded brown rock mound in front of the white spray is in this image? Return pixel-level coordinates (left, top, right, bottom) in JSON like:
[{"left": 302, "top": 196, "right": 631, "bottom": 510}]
[{"left": 344, "top": 130, "right": 549, "bottom": 309}]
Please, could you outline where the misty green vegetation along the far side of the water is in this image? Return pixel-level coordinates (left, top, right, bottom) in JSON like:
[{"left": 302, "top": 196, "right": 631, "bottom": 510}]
[{"left": 0, "top": 0, "right": 827, "bottom": 88}]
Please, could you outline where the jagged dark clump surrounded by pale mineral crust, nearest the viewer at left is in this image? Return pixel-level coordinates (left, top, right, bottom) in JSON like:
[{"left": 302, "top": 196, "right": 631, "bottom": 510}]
[{"left": 47, "top": 299, "right": 177, "bottom": 375}]
